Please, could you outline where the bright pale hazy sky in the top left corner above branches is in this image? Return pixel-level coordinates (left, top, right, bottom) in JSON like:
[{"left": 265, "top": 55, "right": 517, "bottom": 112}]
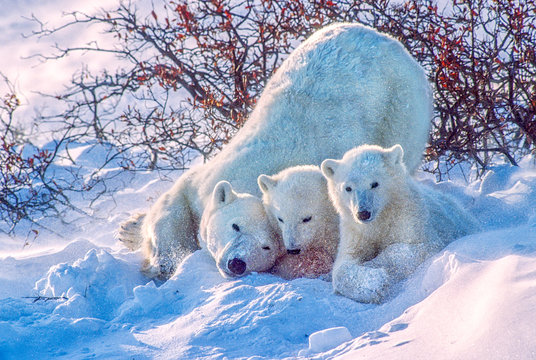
[{"left": 0, "top": 0, "right": 117, "bottom": 121}]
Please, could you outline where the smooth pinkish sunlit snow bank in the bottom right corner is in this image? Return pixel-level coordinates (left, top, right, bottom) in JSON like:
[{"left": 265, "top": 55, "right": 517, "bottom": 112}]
[{"left": 315, "top": 225, "right": 536, "bottom": 359}]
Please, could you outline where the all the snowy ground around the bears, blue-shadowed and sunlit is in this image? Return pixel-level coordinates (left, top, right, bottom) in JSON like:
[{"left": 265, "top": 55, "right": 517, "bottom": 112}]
[{"left": 0, "top": 148, "right": 536, "bottom": 359}]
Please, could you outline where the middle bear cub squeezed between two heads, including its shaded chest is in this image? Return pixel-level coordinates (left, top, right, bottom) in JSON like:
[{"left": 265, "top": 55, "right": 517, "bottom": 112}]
[{"left": 257, "top": 165, "right": 339, "bottom": 279}]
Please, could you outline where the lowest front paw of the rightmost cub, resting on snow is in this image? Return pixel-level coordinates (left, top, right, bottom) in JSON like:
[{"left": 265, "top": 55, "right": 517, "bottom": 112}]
[{"left": 333, "top": 259, "right": 390, "bottom": 303}]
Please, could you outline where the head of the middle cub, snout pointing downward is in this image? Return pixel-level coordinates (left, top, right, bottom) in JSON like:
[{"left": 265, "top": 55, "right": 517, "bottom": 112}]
[{"left": 257, "top": 166, "right": 337, "bottom": 254}]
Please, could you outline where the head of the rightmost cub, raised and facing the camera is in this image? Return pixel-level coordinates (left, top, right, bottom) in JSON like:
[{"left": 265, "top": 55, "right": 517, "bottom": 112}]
[{"left": 321, "top": 145, "right": 406, "bottom": 224}]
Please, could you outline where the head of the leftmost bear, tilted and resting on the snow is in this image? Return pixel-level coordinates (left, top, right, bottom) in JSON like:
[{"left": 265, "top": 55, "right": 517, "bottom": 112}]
[{"left": 200, "top": 181, "right": 282, "bottom": 277}]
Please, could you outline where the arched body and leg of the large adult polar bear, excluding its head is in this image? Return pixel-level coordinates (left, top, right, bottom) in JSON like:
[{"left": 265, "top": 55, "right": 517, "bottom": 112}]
[{"left": 119, "top": 24, "right": 431, "bottom": 277}]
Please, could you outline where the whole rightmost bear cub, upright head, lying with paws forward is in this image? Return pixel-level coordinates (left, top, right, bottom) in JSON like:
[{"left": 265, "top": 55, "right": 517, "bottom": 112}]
[{"left": 321, "top": 145, "right": 479, "bottom": 303}]
